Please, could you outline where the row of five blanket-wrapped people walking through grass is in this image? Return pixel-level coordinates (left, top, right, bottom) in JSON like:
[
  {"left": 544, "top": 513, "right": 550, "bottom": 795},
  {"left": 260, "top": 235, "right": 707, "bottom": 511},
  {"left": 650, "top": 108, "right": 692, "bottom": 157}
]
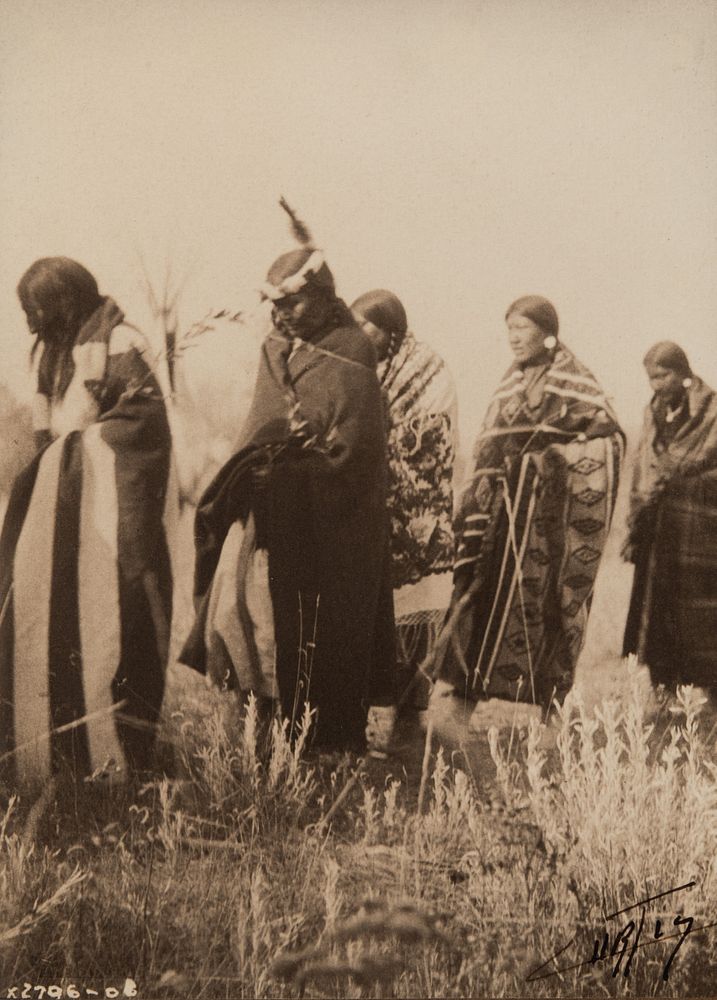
[{"left": 0, "top": 245, "right": 717, "bottom": 784}]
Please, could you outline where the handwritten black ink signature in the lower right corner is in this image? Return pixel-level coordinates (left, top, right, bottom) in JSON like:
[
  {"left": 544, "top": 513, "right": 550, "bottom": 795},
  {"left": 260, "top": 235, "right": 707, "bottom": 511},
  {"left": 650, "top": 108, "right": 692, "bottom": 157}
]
[{"left": 526, "top": 882, "right": 717, "bottom": 983}]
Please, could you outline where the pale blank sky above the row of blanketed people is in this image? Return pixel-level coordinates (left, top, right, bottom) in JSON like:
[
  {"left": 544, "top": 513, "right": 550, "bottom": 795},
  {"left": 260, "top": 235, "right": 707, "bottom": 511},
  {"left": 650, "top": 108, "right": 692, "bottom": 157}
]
[{"left": 0, "top": 0, "right": 717, "bottom": 446}]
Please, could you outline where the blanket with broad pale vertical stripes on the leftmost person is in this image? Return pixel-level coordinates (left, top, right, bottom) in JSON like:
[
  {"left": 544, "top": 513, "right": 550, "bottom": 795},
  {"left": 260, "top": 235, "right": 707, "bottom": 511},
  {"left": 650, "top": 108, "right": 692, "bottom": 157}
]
[{"left": 0, "top": 299, "right": 171, "bottom": 784}]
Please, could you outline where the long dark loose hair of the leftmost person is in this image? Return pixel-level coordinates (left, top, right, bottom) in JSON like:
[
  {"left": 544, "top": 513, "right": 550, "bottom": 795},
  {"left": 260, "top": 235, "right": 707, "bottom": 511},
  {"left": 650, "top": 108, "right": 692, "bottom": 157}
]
[{"left": 17, "top": 257, "right": 102, "bottom": 398}]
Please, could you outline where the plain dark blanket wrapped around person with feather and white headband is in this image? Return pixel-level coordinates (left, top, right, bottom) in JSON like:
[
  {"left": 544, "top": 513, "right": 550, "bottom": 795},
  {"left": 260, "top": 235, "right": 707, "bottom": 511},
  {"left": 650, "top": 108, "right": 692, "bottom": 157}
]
[{"left": 181, "top": 327, "right": 395, "bottom": 747}]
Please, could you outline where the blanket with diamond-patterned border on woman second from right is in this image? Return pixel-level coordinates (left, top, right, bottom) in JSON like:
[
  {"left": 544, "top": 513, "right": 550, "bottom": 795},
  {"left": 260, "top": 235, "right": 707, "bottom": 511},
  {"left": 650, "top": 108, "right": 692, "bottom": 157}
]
[{"left": 433, "top": 346, "right": 623, "bottom": 707}]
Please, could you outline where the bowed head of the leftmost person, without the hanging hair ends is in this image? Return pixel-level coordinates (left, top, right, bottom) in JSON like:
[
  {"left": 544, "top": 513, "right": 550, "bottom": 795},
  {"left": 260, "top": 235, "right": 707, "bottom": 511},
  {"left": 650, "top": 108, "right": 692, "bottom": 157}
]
[{"left": 17, "top": 257, "right": 102, "bottom": 345}]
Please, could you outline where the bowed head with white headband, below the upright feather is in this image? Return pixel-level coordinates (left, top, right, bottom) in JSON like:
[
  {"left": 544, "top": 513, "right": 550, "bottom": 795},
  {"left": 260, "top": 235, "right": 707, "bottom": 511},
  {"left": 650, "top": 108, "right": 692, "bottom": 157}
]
[{"left": 262, "top": 247, "right": 338, "bottom": 340}]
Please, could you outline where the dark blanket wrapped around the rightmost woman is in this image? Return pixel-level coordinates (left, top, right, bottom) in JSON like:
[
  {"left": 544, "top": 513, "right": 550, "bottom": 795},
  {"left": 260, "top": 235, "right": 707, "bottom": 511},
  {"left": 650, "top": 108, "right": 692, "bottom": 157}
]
[{"left": 624, "top": 378, "right": 717, "bottom": 688}]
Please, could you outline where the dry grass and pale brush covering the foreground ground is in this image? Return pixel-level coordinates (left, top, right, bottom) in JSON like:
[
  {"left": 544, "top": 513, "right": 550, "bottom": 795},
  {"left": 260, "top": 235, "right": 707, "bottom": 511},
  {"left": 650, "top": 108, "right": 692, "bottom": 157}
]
[{"left": 0, "top": 440, "right": 717, "bottom": 1000}]
